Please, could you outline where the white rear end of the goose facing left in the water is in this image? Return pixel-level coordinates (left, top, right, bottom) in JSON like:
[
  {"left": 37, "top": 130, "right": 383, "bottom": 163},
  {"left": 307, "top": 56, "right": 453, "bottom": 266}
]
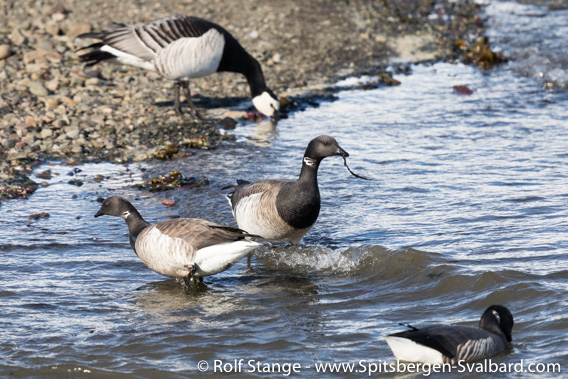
[{"left": 195, "top": 240, "right": 261, "bottom": 276}]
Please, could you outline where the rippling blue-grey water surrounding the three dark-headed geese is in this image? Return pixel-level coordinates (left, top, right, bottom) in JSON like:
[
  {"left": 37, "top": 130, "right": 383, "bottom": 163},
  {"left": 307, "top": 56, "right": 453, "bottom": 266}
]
[{"left": 0, "top": 1, "right": 568, "bottom": 378}]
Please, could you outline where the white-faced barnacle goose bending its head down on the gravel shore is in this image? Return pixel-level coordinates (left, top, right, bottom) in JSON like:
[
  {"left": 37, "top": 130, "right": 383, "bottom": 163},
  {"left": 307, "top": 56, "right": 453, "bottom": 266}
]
[{"left": 77, "top": 17, "right": 280, "bottom": 118}]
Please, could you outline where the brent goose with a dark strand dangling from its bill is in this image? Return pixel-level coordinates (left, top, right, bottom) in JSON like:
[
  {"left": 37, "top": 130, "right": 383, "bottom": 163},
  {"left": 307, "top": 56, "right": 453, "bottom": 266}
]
[{"left": 227, "top": 136, "right": 349, "bottom": 244}]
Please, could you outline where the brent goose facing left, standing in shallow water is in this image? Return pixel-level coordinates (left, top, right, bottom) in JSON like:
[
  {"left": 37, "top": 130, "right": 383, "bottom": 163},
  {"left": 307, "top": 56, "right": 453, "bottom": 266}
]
[{"left": 95, "top": 196, "right": 261, "bottom": 287}]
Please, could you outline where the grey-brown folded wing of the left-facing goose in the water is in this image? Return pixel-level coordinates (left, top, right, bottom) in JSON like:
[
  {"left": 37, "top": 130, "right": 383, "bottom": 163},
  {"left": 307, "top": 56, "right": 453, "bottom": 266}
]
[{"left": 155, "top": 218, "right": 251, "bottom": 250}]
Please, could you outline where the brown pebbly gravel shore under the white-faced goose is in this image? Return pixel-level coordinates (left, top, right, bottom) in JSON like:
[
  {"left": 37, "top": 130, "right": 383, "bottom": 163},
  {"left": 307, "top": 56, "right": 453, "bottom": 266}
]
[{"left": 0, "top": 0, "right": 484, "bottom": 200}]
